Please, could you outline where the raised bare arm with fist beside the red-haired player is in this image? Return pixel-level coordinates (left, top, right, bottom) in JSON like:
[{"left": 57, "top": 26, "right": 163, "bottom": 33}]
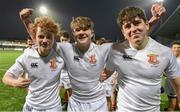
[{"left": 19, "top": 8, "right": 36, "bottom": 42}]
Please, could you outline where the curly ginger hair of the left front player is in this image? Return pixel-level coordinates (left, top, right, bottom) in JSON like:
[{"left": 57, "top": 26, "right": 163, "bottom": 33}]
[{"left": 34, "top": 16, "right": 61, "bottom": 35}]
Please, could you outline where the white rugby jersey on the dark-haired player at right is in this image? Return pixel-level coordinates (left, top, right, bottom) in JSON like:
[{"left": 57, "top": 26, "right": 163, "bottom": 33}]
[{"left": 107, "top": 37, "right": 180, "bottom": 112}]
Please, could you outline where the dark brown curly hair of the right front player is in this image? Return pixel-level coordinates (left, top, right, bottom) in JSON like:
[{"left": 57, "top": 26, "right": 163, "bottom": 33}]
[{"left": 117, "top": 7, "right": 147, "bottom": 28}]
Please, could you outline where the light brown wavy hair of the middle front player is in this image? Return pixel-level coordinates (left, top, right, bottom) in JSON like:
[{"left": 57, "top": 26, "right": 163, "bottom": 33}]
[{"left": 70, "top": 16, "right": 94, "bottom": 29}]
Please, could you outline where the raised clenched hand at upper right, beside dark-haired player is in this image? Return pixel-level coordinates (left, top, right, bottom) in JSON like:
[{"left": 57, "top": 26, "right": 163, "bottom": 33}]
[{"left": 151, "top": 3, "right": 166, "bottom": 19}]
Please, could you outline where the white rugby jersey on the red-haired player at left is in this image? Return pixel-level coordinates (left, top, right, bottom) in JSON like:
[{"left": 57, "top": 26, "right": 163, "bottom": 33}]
[{"left": 7, "top": 49, "right": 64, "bottom": 110}]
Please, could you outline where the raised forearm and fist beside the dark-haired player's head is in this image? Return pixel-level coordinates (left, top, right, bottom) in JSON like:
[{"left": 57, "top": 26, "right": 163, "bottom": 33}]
[{"left": 149, "top": 3, "right": 166, "bottom": 28}]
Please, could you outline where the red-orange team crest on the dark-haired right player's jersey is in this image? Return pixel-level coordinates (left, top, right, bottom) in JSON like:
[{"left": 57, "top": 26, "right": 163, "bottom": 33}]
[{"left": 147, "top": 54, "right": 159, "bottom": 65}]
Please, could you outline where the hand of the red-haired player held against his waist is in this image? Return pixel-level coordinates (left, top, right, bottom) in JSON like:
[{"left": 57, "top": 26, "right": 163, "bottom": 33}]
[{"left": 13, "top": 74, "right": 31, "bottom": 88}]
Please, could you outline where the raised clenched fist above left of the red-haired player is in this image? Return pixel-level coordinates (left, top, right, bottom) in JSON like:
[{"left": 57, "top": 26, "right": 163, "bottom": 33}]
[{"left": 19, "top": 8, "right": 33, "bottom": 19}]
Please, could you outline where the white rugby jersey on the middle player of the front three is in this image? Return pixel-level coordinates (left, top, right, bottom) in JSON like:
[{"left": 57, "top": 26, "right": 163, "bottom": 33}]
[{"left": 57, "top": 43, "right": 111, "bottom": 102}]
